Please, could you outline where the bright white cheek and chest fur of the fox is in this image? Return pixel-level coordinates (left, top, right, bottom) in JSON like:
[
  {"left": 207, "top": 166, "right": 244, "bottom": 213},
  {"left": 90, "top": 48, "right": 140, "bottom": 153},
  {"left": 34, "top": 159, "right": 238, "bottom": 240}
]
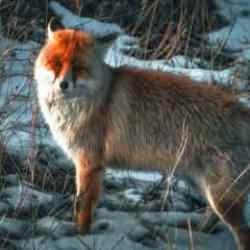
[{"left": 35, "top": 65, "right": 96, "bottom": 158}]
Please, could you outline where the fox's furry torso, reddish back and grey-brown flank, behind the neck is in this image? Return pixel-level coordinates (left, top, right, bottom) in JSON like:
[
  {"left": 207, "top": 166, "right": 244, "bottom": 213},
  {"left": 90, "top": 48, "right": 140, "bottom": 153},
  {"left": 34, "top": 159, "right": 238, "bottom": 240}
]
[{"left": 106, "top": 67, "right": 250, "bottom": 171}]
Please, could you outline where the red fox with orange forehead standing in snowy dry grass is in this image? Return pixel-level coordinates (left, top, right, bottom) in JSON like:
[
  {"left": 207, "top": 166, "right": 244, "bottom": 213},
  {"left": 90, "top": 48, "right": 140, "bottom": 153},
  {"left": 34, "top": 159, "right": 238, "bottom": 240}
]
[{"left": 34, "top": 26, "right": 250, "bottom": 250}]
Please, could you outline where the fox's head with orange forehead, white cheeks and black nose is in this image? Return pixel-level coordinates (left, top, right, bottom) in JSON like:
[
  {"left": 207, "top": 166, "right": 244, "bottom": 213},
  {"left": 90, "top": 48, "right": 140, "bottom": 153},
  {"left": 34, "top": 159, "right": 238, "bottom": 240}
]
[{"left": 34, "top": 25, "right": 114, "bottom": 106}]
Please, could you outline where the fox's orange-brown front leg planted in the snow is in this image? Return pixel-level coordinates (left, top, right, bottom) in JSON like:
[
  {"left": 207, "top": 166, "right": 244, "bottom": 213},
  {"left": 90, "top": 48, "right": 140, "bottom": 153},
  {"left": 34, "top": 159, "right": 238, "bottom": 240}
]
[{"left": 74, "top": 154, "right": 103, "bottom": 233}]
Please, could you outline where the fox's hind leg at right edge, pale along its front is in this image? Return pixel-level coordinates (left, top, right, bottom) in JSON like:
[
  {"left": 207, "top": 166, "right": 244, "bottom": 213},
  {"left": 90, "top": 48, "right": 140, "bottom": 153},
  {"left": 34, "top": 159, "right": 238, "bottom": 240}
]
[{"left": 201, "top": 151, "right": 250, "bottom": 250}]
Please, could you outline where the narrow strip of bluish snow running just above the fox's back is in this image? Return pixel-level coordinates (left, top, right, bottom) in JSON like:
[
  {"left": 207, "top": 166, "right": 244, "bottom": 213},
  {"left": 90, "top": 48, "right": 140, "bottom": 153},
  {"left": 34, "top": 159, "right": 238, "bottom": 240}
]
[{"left": 105, "top": 32, "right": 238, "bottom": 86}]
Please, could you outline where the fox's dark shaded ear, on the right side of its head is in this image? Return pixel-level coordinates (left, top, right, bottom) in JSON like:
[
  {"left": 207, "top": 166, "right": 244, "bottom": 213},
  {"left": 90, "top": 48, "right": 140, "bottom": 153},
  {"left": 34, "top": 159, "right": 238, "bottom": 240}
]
[{"left": 95, "top": 33, "right": 119, "bottom": 59}]
